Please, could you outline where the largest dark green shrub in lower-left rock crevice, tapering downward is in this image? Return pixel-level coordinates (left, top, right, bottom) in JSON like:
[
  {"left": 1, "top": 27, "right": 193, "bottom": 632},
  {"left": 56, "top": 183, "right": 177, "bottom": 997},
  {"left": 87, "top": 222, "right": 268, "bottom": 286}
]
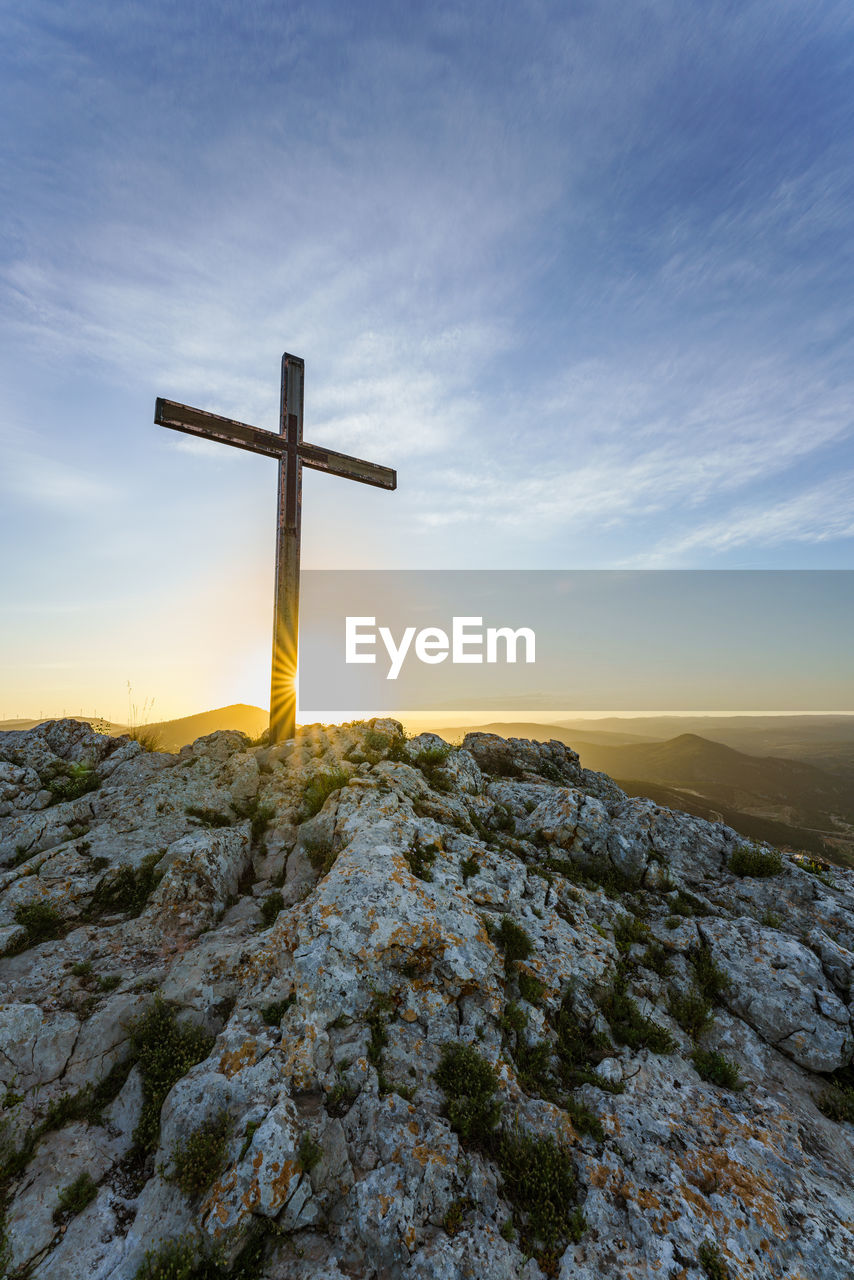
[{"left": 129, "top": 995, "right": 214, "bottom": 1155}]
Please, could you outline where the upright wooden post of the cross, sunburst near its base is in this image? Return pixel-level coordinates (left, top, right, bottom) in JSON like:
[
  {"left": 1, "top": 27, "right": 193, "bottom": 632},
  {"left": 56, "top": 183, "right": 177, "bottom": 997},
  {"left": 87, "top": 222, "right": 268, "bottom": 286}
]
[{"left": 270, "top": 352, "right": 305, "bottom": 742}]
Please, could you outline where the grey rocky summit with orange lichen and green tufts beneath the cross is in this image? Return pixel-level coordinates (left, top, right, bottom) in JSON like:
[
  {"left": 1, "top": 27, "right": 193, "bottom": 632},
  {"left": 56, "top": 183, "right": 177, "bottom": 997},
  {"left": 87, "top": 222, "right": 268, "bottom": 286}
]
[{"left": 0, "top": 719, "right": 854, "bottom": 1280}]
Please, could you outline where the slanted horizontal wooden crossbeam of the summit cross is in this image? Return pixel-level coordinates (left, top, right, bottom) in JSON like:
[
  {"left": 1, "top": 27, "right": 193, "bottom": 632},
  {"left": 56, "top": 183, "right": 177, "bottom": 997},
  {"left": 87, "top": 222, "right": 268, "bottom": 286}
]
[{"left": 154, "top": 396, "right": 397, "bottom": 489}]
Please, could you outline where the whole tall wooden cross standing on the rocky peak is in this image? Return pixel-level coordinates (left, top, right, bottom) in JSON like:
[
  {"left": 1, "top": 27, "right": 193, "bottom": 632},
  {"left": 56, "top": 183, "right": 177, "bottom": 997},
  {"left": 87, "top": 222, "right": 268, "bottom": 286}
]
[{"left": 154, "top": 352, "right": 397, "bottom": 742}]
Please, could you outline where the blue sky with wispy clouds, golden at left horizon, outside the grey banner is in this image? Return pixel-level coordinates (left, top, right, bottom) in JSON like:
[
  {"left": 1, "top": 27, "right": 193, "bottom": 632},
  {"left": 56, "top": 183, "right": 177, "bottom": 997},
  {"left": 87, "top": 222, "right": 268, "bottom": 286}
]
[{"left": 0, "top": 0, "right": 854, "bottom": 718}]
